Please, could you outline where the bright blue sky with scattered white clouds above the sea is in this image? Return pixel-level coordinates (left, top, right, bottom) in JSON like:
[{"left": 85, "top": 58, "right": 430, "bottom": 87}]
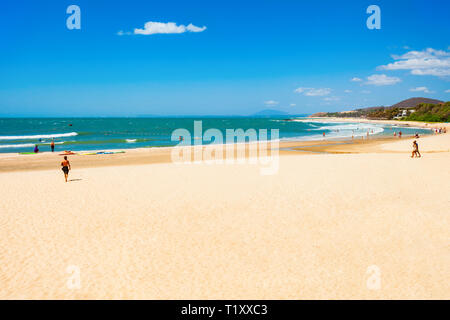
[{"left": 0, "top": 0, "right": 450, "bottom": 116}]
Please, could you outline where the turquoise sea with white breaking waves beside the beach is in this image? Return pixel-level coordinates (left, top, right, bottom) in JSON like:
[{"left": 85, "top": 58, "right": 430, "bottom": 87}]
[{"left": 0, "top": 117, "right": 429, "bottom": 153}]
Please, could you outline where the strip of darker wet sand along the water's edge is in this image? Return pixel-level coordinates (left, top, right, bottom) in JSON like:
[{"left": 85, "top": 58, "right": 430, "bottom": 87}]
[{"left": 0, "top": 134, "right": 442, "bottom": 173}]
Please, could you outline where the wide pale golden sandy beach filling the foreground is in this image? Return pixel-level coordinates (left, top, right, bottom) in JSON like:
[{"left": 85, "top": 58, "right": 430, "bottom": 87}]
[{"left": 0, "top": 119, "right": 450, "bottom": 299}]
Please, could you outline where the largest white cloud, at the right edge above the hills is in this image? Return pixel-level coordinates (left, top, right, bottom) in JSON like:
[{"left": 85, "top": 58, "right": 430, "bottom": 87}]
[{"left": 378, "top": 48, "right": 450, "bottom": 77}]
